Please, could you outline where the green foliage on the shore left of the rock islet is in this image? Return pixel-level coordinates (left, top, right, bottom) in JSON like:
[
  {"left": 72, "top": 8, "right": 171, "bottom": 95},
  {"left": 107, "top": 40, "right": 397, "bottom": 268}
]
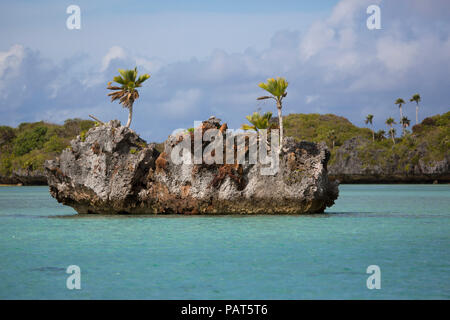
[{"left": 0, "top": 119, "right": 94, "bottom": 176}]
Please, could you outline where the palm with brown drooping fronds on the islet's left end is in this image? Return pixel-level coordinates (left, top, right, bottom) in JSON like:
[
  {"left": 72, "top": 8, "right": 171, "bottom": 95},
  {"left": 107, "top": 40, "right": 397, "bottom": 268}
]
[{"left": 107, "top": 67, "right": 150, "bottom": 128}]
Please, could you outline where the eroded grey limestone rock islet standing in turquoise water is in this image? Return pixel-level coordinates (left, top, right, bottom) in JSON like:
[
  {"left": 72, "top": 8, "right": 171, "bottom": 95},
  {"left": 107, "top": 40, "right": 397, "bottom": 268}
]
[{"left": 45, "top": 117, "right": 338, "bottom": 214}]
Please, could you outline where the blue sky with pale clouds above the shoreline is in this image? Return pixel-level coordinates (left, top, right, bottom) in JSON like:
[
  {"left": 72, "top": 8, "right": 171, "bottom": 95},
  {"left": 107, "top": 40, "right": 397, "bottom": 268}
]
[{"left": 0, "top": 0, "right": 450, "bottom": 141}]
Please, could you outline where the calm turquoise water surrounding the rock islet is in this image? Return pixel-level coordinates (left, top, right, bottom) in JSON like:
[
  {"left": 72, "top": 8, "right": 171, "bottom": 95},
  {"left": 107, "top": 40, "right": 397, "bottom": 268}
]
[{"left": 0, "top": 185, "right": 450, "bottom": 299}]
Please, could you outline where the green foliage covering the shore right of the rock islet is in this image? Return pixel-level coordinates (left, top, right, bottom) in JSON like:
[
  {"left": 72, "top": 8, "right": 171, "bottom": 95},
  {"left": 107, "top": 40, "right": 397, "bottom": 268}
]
[{"left": 284, "top": 112, "right": 450, "bottom": 169}]
